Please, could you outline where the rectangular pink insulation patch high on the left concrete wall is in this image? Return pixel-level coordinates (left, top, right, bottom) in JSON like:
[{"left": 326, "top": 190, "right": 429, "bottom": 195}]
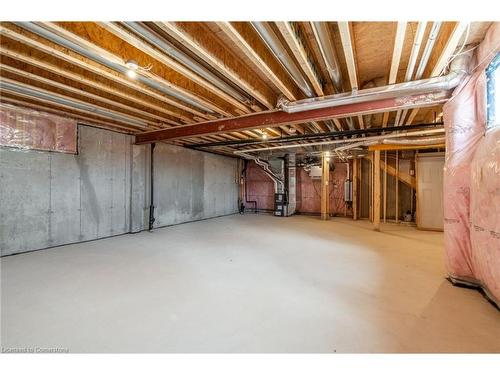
[{"left": 0, "top": 104, "right": 77, "bottom": 154}]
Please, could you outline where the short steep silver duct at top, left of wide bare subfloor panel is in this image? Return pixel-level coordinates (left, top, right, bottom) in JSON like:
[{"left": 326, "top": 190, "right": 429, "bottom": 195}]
[{"left": 311, "top": 21, "right": 342, "bottom": 93}]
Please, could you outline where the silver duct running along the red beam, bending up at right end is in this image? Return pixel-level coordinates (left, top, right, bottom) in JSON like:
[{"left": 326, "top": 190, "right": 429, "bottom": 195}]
[{"left": 279, "top": 52, "right": 472, "bottom": 113}]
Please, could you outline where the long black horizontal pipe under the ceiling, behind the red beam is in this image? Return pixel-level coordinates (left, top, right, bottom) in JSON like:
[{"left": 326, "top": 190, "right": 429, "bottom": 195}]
[{"left": 184, "top": 122, "right": 443, "bottom": 149}]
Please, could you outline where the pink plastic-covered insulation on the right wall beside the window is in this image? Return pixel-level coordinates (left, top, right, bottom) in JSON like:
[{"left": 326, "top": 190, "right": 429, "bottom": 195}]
[{"left": 443, "top": 23, "right": 500, "bottom": 306}]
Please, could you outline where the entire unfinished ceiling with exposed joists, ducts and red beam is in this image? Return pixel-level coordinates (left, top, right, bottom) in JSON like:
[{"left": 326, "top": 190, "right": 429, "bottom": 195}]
[{"left": 0, "top": 21, "right": 489, "bottom": 155}]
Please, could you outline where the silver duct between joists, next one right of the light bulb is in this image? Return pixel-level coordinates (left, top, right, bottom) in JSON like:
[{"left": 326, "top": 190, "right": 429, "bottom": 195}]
[{"left": 124, "top": 22, "right": 250, "bottom": 103}]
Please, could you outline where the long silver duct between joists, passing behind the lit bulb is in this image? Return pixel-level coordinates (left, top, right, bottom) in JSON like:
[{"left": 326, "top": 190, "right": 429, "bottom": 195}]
[{"left": 14, "top": 22, "right": 214, "bottom": 113}]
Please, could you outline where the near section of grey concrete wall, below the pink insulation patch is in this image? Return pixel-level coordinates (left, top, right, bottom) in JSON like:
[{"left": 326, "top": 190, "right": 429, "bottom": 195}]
[{"left": 0, "top": 126, "right": 132, "bottom": 255}]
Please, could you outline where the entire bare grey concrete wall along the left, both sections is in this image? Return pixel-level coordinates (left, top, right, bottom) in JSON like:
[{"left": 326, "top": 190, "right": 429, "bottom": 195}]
[{"left": 0, "top": 126, "right": 238, "bottom": 255}]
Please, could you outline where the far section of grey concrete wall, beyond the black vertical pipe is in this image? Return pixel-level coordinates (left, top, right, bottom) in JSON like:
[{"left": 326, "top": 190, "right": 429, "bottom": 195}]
[{"left": 154, "top": 143, "right": 239, "bottom": 227}]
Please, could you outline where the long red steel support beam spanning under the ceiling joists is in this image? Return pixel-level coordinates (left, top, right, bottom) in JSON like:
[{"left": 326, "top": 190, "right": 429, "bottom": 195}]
[{"left": 136, "top": 93, "right": 448, "bottom": 144}]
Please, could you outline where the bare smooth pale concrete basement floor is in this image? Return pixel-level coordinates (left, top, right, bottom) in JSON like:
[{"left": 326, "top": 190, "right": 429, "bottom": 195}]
[{"left": 1, "top": 214, "right": 500, "bottom": 353}]
